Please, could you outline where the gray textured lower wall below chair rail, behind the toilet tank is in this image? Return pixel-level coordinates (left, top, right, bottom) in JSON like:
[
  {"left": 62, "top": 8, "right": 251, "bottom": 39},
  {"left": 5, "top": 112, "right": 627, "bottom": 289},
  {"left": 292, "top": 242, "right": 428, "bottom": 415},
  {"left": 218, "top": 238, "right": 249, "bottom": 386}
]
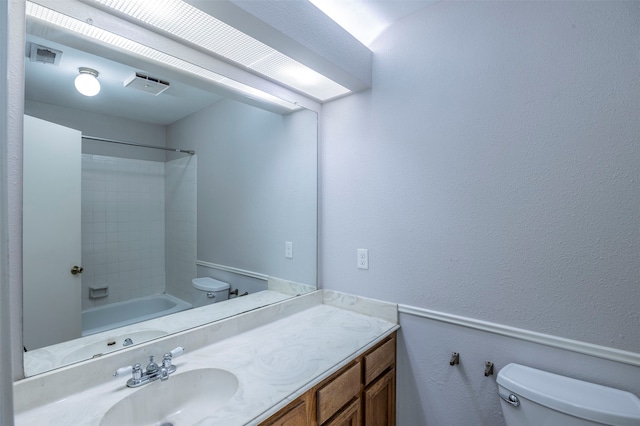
[{"left": 397, "top": 314, "right": 640, "bottom": 426}]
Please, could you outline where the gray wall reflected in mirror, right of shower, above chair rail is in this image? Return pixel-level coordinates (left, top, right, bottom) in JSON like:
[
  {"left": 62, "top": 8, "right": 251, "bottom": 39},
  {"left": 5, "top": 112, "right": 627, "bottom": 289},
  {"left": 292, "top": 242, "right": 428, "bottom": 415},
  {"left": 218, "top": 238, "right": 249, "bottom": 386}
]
[{"left": 167, "top": 100, "right": 317, "bottom": 284}]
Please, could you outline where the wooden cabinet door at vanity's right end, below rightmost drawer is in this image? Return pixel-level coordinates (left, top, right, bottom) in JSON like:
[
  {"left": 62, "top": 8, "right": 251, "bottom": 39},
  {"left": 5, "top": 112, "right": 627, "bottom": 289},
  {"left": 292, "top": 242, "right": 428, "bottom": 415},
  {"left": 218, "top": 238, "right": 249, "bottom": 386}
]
[{"left": 364, "top": 368, "right": 396, "bottom": 426}]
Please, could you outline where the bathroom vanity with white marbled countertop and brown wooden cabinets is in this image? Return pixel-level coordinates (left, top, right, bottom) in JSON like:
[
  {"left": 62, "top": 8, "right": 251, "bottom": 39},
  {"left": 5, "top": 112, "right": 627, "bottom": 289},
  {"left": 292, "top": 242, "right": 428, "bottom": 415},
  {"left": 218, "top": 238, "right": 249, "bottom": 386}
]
[{"left": 14, "top": 291, "right": 398, "bottom": 426}]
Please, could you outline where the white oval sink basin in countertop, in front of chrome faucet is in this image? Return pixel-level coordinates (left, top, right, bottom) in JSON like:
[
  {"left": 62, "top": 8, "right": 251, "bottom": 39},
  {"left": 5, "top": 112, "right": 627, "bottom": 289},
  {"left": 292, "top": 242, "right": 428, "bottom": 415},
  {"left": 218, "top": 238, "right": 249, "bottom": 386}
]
[{"left": 100, "top": 368, "right": 238, "bottom": 426}]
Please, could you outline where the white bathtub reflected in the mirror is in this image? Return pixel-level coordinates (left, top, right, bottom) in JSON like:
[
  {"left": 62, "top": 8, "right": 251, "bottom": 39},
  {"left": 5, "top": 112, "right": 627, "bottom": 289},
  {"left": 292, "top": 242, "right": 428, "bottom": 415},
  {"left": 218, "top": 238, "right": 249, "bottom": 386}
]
[{"left": 82, "top": 294, "right": 191, "bottom": 336}]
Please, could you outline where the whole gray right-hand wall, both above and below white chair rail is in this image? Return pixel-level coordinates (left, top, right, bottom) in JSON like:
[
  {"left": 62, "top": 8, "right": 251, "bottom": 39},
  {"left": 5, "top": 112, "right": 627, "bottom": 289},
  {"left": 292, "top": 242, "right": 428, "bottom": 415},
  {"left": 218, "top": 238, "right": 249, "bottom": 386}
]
[{"left": 321, "top": 2, "right": 640, "bottom": 426}]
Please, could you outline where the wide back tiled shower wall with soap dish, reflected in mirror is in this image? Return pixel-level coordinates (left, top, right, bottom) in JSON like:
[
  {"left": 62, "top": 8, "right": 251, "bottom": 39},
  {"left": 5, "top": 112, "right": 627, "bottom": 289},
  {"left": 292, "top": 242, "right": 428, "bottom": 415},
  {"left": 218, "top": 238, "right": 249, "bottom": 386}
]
[{"left": 82, "top": 154, "right": 165, "bottom": 309}]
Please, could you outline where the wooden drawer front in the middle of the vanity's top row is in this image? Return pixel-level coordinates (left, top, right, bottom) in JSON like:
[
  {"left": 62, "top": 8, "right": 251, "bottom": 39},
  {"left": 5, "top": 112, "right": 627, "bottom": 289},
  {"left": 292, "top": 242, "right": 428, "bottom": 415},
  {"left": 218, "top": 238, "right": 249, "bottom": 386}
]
[{"left": 316, "top": 362, "right": 361, "bottom": 424}]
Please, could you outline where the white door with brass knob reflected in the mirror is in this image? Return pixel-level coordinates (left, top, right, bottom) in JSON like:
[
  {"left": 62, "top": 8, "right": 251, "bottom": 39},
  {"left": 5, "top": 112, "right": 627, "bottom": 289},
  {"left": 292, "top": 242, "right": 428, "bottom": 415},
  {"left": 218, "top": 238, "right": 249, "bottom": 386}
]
[{"left": 22, "top": 116, "right": 82, "bottom": 350}]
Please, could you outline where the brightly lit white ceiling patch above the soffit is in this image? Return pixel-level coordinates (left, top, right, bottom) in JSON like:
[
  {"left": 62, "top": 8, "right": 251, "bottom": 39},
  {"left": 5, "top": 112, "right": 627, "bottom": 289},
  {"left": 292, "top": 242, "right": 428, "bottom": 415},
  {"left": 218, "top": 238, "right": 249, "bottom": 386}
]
[{"left": 309, "top": 0, "right": 440, "bottom": 46}]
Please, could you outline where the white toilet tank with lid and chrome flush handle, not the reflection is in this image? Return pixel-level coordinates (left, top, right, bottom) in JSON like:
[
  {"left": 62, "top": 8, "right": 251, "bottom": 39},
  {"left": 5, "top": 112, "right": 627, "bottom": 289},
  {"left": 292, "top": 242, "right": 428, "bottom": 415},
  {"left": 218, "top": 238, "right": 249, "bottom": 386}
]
[{"left": 497, "top": 364, "right": 640, "bottom": 426}]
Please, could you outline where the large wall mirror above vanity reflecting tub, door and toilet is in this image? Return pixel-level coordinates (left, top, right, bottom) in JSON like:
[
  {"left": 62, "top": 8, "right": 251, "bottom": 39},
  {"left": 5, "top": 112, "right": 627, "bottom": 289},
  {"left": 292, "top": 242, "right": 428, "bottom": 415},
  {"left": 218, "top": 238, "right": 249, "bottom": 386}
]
[{"left": 23, "top": 2, "right": 317, "bottom": 376}]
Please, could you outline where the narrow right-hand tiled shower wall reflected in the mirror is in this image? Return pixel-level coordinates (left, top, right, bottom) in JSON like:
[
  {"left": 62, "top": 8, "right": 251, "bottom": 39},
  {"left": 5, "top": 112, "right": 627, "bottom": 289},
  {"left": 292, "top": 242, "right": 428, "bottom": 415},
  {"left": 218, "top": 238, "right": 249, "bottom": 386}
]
[{"left": 165, "top": 155, "right": 197, "bottom": 303}]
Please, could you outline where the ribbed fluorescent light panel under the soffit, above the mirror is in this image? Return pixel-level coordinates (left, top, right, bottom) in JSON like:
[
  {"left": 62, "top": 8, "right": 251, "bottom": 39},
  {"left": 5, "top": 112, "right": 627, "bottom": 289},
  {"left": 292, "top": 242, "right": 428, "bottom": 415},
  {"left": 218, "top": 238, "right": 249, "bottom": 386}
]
[{"left": 87, "top": 0, "right": 351, "bottom": 101}]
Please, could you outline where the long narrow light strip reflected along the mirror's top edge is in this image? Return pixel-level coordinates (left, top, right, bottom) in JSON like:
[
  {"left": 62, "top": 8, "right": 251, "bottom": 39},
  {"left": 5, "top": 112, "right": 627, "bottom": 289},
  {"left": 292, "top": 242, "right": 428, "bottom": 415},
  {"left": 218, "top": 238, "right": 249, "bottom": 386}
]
[{"left": 26, "top": 1, "right": 300, "bottom": 111}]
